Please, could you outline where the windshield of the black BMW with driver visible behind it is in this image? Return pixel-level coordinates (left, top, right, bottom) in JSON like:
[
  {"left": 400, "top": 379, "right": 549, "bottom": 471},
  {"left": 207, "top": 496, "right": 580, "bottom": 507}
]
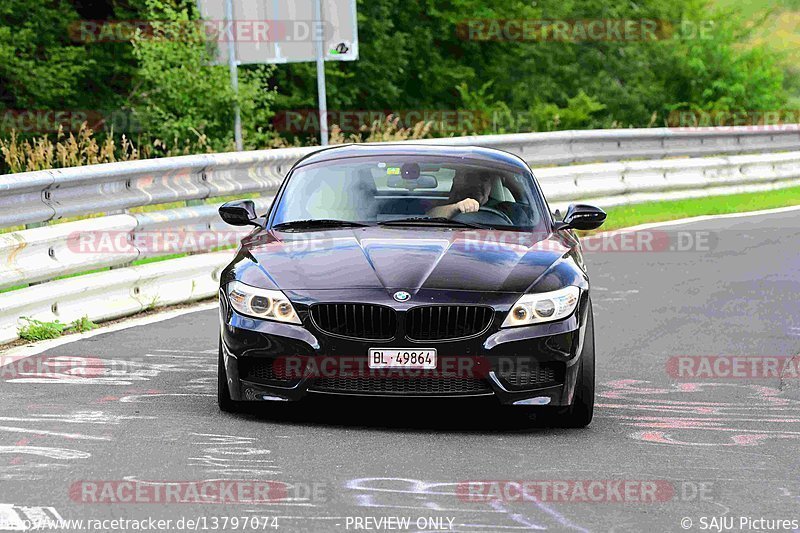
[{"left": 272, "top": 156, "right": 545, "bottom": 230}]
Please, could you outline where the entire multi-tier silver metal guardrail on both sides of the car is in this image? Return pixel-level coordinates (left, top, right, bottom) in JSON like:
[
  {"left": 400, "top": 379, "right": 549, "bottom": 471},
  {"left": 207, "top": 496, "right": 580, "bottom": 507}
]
[{"left": 0, "top": 126, "right": 800, "bottom": 342}]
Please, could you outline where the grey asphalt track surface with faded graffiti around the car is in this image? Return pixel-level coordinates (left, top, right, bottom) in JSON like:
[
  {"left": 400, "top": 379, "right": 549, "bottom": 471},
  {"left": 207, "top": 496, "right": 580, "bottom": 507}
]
[{"left": 0, "top": 211, "right": 800, "bottom": 532}]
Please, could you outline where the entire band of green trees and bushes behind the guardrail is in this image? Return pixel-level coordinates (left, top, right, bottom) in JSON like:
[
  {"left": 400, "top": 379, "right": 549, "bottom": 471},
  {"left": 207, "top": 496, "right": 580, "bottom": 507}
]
[{"left": 0, "top": 0, "right": 800, "bottom": 164}]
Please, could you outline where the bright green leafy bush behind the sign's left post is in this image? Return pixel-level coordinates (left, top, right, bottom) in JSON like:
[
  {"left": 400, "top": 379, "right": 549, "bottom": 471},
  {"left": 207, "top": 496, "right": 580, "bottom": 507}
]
[{"left": 129, "top": 0, "right": 273, "bottom": 150}]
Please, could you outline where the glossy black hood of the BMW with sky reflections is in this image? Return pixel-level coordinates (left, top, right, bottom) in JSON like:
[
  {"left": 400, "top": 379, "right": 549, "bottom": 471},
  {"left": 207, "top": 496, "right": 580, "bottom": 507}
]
[{"left": 241, "top": 227, "right": 570, "bottom": 293}]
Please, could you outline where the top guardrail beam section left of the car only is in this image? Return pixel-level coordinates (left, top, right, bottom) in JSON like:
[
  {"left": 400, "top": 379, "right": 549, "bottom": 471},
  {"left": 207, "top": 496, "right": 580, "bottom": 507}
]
[{"left": 0, "top": 147, "right": 315, "bottom": 227}]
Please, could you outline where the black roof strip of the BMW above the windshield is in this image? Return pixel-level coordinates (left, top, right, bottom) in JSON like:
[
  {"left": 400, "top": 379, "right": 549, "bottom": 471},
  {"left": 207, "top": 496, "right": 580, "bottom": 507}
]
[{"left": 294, "top": 142, "right": 528, "bottom": 171}]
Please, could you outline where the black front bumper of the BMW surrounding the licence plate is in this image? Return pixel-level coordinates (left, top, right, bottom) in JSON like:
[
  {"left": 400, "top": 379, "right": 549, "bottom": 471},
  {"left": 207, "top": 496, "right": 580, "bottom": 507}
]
[{"left": 220, "top": 288, "right": 587, "bottom": 406}]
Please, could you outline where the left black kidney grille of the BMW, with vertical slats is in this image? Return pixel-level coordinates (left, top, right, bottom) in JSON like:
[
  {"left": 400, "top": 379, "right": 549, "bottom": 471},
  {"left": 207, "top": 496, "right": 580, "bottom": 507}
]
[{"left": 311, "top": 304, "right": 397, "bottom": 340}]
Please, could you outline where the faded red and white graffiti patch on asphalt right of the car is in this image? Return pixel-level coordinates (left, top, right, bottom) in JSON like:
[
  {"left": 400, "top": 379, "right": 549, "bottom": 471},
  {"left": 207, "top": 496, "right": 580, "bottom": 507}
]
[{"left": 597, "top": 379, "right": 800, "bottom": 447}]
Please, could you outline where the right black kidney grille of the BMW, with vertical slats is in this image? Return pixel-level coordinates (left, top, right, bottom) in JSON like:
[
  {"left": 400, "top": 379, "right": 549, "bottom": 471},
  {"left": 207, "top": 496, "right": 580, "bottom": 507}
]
[{"left": 406, "top": 305, "right": 494, "bottom": 341}]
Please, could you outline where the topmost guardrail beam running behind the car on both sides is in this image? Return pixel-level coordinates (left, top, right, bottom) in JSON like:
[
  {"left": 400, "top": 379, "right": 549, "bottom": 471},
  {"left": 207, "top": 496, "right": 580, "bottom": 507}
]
[{"left": 0, "top": 126, "right": 800, "bottom": 227}]
